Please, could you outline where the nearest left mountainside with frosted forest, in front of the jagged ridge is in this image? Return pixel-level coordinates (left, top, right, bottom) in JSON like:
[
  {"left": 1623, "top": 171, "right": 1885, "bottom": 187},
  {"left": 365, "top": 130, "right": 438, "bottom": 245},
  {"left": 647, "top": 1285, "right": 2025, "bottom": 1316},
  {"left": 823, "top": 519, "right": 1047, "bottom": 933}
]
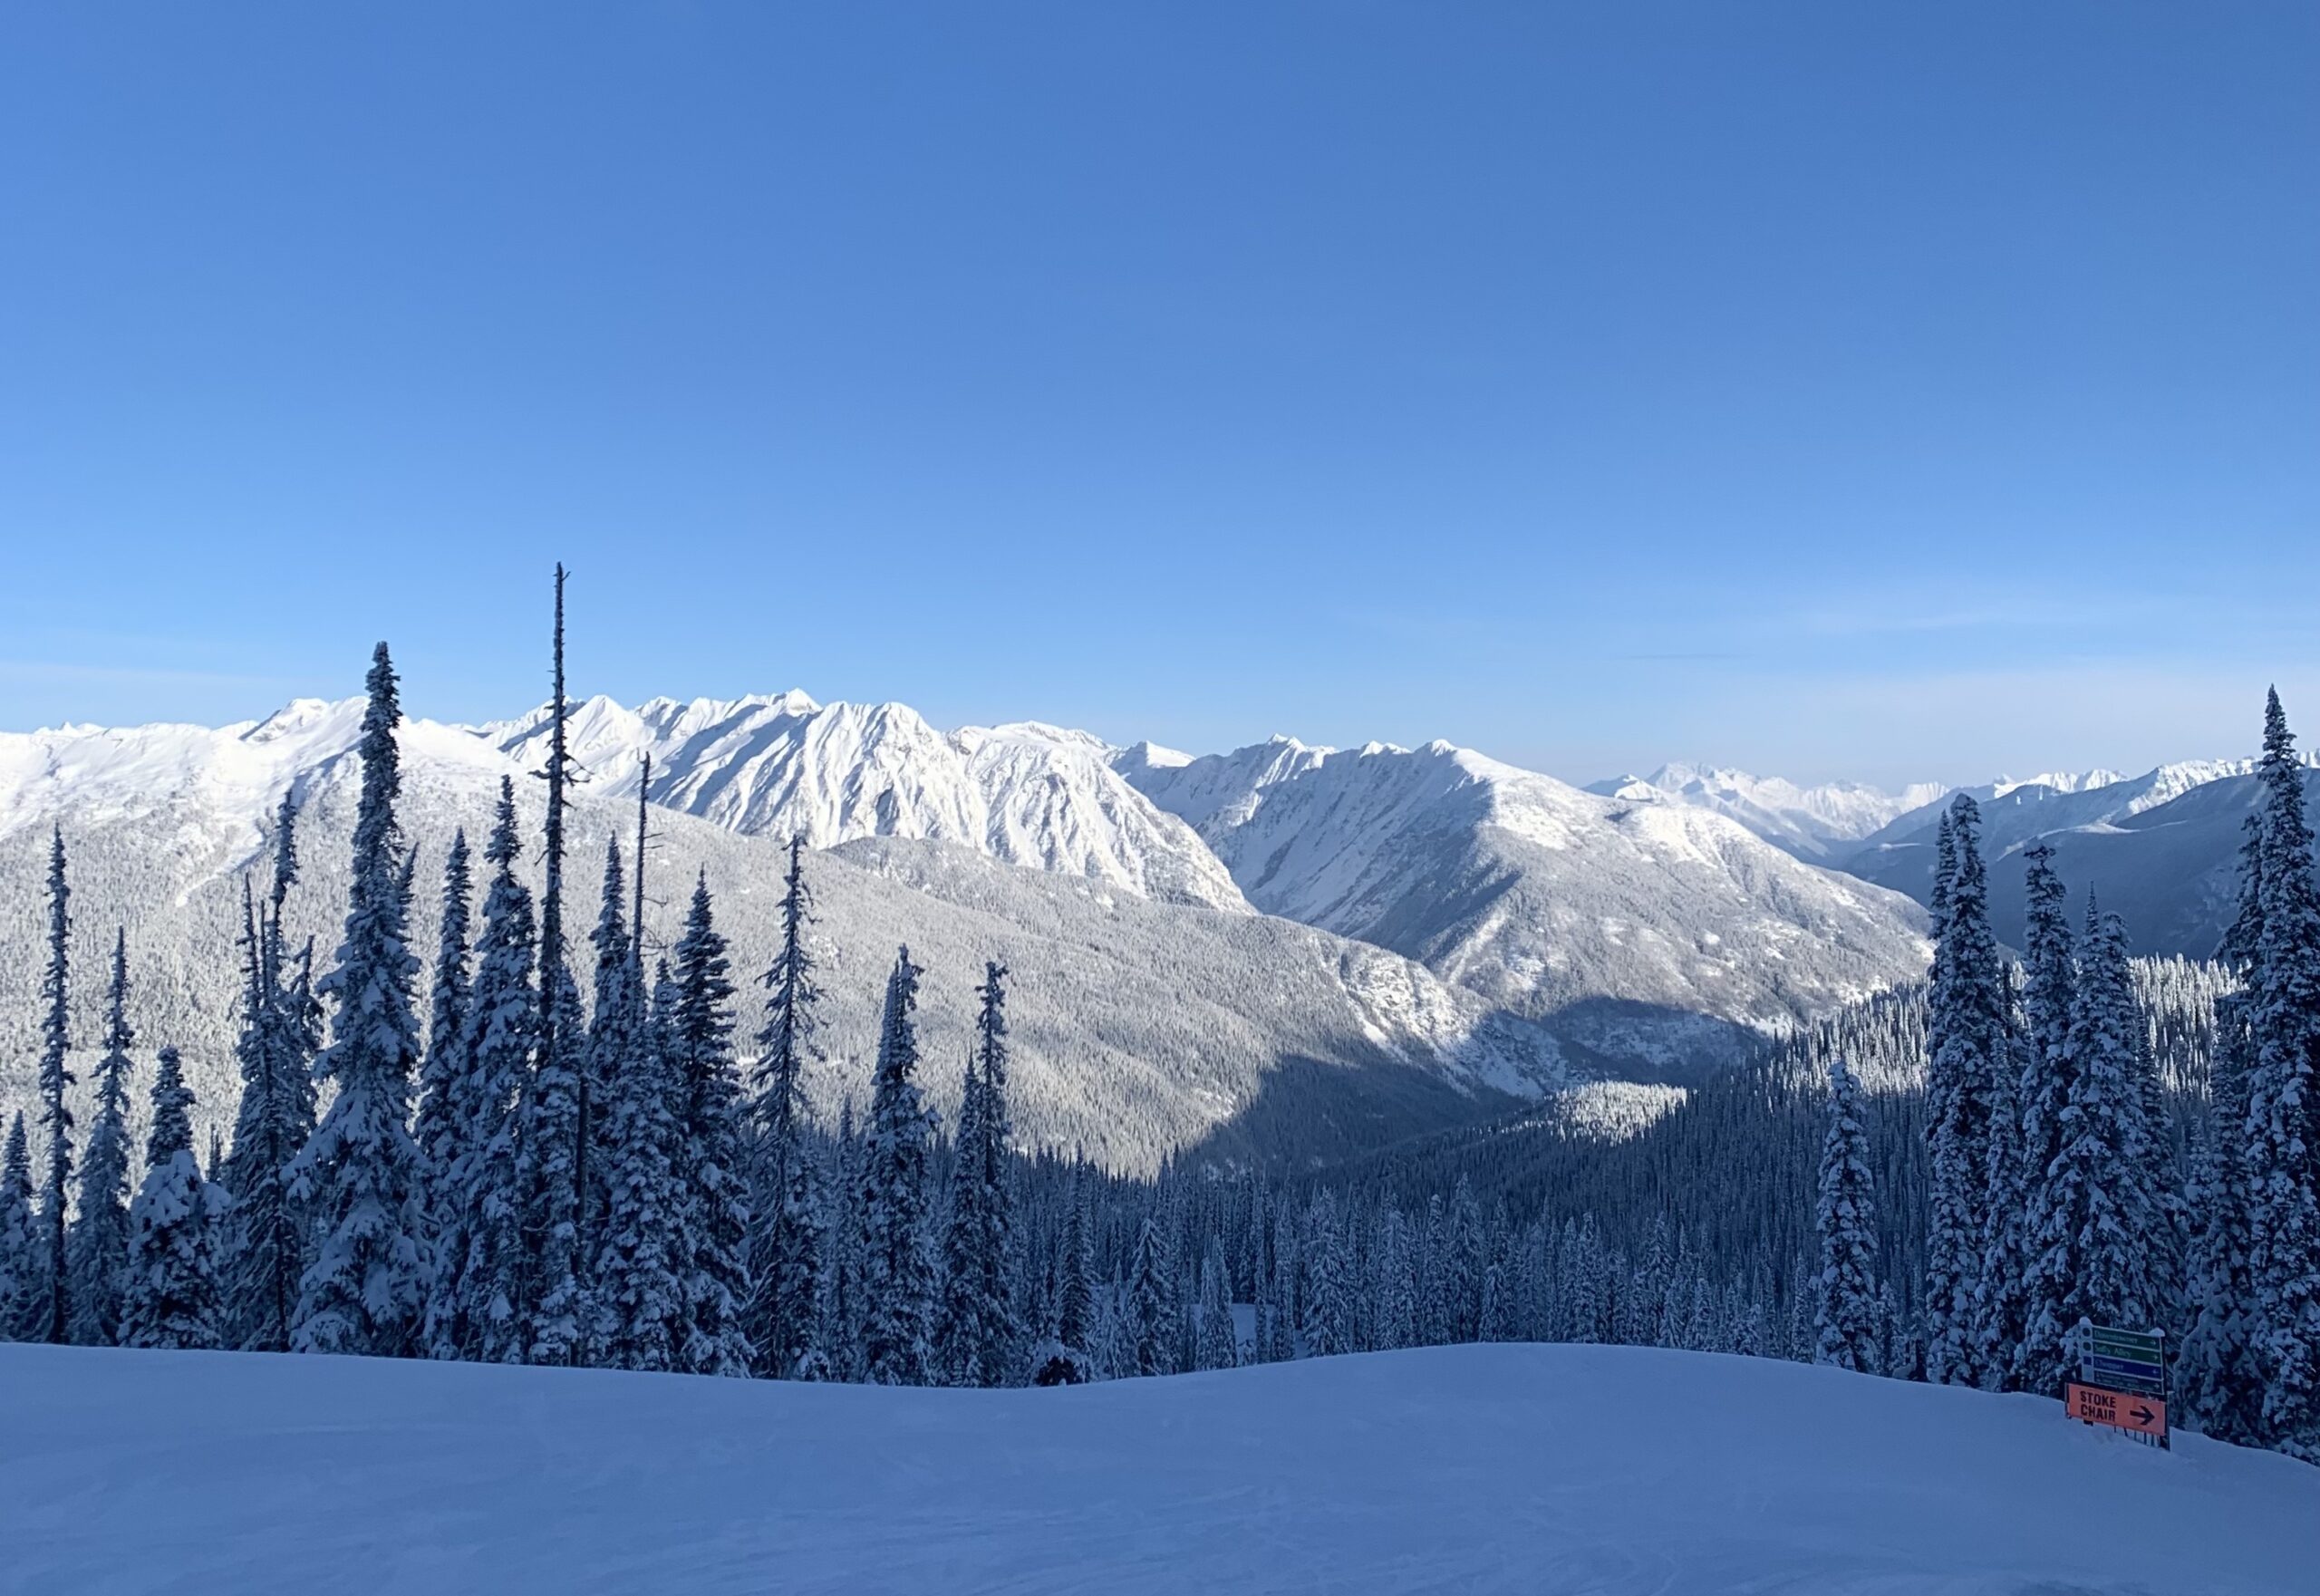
[{"left": 0, "top": 703, "right": 1561, "bottom": 1169}]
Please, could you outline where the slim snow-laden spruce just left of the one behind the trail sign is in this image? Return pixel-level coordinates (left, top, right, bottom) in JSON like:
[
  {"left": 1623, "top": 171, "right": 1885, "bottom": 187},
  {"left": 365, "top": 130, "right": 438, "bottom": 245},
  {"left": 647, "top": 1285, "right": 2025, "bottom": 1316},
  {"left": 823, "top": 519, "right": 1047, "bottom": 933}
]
[{"left": 2014, "top": 842, "right": 2079, "bottom": 1394}]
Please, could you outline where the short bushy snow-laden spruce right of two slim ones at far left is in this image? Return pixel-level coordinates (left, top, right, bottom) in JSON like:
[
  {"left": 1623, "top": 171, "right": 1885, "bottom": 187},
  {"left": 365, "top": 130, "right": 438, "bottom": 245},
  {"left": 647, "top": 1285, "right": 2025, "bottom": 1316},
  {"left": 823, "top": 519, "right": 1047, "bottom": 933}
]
[{"left": 121, "top": 1046, "right": 225, "bottom": 1348}]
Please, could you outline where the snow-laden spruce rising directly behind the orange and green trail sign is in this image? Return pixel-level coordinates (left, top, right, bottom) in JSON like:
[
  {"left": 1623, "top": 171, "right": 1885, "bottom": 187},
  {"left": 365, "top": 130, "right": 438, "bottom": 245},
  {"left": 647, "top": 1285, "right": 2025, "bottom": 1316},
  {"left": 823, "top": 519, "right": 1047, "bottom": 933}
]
[{"left": 2025, "top": 891, "right": 2158, "bottom": 1369}]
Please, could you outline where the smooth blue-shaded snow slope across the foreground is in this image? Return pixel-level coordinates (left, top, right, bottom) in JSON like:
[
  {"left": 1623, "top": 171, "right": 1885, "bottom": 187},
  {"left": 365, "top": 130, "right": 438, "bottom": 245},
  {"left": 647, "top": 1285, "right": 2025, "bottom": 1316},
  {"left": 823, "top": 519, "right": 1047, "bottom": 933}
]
[{"left": 0, "top": 1346, "right": 2320, "bottom": 1596}]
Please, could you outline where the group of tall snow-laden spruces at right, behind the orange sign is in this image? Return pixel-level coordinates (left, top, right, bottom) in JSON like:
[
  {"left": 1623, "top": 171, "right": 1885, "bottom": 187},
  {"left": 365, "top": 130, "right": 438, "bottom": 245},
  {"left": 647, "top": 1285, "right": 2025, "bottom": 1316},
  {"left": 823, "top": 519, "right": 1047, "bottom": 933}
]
[{"left": 1814, "top": 693, "right": 2320, "bottom": 1456}]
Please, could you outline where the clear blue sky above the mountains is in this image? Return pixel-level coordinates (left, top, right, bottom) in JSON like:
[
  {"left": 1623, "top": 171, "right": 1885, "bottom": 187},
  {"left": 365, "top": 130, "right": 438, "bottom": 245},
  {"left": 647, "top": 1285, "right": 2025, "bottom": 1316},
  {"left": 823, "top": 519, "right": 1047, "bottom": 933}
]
[{"left": 0, "top": 0, "right": 2320, "bottom": 779}]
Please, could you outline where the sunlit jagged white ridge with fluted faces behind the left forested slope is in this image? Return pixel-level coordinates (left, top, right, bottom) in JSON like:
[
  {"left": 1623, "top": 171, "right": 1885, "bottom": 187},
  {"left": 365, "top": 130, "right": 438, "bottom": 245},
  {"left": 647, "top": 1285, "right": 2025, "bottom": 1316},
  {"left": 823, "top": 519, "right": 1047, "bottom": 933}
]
[{"left": 478, "top": 692, "right": 1246, "bottom": 909}]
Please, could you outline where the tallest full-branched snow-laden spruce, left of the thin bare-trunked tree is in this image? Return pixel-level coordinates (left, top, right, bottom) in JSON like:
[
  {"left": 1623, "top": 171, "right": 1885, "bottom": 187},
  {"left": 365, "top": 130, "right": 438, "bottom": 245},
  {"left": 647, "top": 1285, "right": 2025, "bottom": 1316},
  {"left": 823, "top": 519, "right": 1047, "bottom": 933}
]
[{"left": 290, "top": 643, "right": 430, "bottom": 1357}]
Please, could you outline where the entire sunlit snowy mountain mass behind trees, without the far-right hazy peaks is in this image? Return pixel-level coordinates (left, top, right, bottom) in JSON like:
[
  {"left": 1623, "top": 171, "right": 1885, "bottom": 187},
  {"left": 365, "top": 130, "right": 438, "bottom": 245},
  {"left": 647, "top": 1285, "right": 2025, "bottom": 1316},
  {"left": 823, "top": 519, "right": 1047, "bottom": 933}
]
[{"left": 0, "top": 693, "right": 1926, "bottom": 1166}]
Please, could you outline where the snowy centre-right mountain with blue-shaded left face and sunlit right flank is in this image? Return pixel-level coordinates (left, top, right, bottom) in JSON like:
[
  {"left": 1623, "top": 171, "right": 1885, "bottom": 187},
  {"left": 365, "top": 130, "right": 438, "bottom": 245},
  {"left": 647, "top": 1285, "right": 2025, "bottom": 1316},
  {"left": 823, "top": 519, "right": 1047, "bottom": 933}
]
[{"left": 1118, "top": 738, "right": 1926, "bottom": 1074}]
